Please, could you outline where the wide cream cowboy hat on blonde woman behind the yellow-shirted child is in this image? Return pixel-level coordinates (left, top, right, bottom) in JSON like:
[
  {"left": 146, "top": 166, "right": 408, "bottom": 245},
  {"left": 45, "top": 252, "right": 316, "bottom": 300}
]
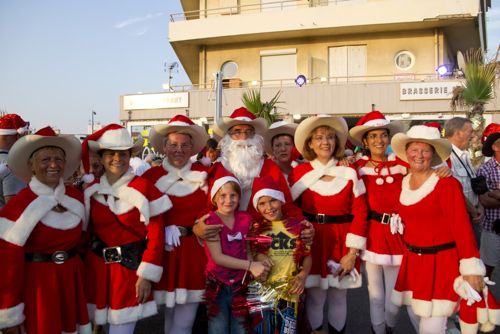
[{"left": 294, "top": 115, "right": 348, "bottom": 154}]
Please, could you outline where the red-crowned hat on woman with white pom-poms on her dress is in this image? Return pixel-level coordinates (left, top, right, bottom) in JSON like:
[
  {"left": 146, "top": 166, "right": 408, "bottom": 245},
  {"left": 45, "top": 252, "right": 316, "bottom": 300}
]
[{"left": 349, "top": 110, "right": 404, "bottom": 147}]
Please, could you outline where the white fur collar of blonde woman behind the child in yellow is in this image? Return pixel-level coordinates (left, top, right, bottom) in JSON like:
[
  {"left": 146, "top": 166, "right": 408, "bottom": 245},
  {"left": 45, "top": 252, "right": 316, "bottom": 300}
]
[{"left": 291, "top": 159, "right": 366, "bottom": 200}]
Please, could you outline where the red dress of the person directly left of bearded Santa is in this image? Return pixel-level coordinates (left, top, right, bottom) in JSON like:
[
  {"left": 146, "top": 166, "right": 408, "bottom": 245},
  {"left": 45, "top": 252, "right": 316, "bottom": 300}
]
[{"left": 143, "top": 160, "right": 207, "bottom": 307}]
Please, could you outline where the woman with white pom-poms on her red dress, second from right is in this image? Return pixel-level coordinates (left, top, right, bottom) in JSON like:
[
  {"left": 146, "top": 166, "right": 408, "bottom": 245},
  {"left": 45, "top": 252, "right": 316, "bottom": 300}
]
[{"left": 349, "top": 111, "right": 408, "bottom": 334}]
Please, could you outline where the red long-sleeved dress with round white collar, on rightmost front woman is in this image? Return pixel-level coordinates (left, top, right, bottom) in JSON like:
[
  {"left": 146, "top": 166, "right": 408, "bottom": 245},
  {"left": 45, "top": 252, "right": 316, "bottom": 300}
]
[{"left": 391, "top": 174, "right": 484, "bottom": 317}]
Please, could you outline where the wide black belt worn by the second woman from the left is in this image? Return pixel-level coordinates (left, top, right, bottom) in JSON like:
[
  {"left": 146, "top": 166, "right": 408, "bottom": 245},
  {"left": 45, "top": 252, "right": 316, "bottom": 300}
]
[{"left": 90, "top": 237, "right": 147, "bottom": 270}]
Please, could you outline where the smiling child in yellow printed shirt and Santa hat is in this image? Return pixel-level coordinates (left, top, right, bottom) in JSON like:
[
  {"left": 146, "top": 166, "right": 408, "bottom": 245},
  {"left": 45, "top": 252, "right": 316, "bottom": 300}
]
[{"left": 248, "top": 176, "right": 312, "bottom": 334}]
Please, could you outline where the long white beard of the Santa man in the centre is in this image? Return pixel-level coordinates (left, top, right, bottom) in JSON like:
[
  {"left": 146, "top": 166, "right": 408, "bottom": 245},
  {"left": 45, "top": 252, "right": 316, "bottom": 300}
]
[{"left": 220, "top": 134, "right": 264, "bottom": 189}]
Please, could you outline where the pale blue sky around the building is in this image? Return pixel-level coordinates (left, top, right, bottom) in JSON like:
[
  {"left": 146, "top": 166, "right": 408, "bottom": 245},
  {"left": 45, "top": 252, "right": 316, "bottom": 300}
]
[{"left": 0, "top": 0, "right": 500, "bottom": 133}]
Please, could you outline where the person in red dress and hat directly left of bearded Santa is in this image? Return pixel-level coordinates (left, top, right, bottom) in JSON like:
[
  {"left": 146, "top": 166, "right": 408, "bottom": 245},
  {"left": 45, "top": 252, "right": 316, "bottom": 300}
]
[{"left": 143, "top": 115, "right": 208, "bottom": 334}]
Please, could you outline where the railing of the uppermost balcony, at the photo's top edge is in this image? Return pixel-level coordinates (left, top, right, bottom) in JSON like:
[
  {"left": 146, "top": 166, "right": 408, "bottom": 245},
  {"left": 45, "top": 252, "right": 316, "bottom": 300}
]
[{"left": 170, "top": 0, "right": 355, "bottom": 22}]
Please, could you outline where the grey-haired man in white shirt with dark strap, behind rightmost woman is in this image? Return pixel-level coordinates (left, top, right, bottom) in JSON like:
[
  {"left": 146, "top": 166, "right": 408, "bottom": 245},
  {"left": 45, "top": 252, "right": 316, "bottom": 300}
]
[{"left": 444, "top": 117, "right": 484, "bottom": 244}]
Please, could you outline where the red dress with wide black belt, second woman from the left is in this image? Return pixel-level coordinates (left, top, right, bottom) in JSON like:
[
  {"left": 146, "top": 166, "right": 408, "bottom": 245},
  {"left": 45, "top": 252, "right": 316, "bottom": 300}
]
[{"left": 85, "top": 173, "right": 171, "bottom": 325}]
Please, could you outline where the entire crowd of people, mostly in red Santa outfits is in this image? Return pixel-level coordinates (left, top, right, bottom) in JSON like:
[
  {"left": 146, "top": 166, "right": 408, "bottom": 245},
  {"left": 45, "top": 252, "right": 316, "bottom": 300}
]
[{"left": 0, "top": 107, "right": 500, "bottom": 334}]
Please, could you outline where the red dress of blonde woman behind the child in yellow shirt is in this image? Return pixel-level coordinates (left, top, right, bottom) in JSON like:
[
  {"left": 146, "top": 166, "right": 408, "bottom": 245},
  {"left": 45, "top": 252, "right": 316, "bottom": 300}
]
[{"left": 289, "top": 160, "right": 367, "bottom": 289}]
